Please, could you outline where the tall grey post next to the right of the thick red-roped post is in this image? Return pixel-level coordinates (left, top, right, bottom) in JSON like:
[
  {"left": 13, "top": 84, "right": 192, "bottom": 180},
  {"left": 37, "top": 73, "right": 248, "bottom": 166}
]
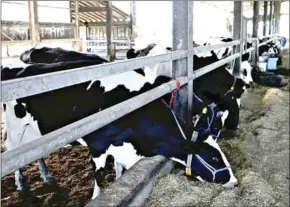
[{"left": 233, "top": 1, "right": 243, "bottom": 74}]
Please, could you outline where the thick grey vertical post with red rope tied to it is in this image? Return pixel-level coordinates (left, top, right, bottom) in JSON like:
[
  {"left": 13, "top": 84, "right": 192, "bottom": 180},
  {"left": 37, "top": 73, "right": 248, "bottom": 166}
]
[{"left": 172, "top": 1, "right": 193, "bottom": 124}]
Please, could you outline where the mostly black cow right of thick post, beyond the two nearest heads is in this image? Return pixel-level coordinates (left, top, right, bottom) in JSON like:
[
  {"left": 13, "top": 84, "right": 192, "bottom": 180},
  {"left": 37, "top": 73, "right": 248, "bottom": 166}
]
[{"left": 127, "top": 44, "right": 251, "bottom": 130}]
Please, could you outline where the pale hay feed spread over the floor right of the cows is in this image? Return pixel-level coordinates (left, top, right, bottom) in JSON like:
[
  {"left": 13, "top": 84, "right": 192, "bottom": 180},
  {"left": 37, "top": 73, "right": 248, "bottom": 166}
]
[{"left": 146, "top": 51, "right": 289, "bottom": 207}]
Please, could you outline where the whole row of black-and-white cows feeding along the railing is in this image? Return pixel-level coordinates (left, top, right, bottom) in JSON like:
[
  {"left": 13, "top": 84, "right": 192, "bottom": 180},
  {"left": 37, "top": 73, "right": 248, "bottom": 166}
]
[{"left": 1, "top": 38, "right": 283, "bottom": 201}]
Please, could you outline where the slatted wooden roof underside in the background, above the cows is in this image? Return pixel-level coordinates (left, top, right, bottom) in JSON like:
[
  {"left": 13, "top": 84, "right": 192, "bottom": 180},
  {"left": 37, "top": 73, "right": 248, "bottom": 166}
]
[{"left": 70, "top": 1, "right": 130, "bottom": 26}]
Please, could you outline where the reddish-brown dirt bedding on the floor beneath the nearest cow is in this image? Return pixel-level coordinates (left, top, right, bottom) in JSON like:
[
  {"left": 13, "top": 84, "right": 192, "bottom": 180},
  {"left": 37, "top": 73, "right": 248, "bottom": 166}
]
[{"left": 1, "top": 146, "right": 115, "bottom": 207}]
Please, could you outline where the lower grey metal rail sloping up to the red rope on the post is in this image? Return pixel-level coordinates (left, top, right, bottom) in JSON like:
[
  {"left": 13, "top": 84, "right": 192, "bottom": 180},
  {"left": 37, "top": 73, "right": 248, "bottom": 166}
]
[{"left": 1, "top": 77, "right": 188, "bottom": 177}]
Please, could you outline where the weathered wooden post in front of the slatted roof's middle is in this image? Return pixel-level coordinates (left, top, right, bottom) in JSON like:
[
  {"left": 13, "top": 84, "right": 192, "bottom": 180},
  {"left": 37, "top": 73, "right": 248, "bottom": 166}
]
[{"left": 106, "top": 1, "right": 115, "bottom": 61}]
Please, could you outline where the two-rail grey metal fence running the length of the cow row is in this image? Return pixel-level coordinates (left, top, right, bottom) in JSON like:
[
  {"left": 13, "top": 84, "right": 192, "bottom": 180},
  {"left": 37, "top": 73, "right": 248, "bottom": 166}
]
[{"left": 1, "top": 34, "right": 280, "bottom": 177}]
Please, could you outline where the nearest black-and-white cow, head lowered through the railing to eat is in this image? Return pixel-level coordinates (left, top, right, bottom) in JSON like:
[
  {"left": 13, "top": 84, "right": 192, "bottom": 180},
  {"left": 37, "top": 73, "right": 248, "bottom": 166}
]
[{"left": 1, "top": 47, "right": 237, "bottom": 198}]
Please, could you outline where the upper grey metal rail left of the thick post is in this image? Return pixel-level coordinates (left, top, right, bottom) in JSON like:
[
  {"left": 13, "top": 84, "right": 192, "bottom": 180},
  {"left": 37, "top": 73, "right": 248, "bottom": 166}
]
[{"left": 1, "top": 51, "right": 187, "bottom": 102}]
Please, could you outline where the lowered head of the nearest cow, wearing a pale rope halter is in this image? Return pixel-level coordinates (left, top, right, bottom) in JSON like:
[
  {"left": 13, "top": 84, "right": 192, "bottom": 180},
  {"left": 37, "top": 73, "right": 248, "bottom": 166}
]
[{"left": 187, "top": 129, "right": 238, "bottom": 188}]
